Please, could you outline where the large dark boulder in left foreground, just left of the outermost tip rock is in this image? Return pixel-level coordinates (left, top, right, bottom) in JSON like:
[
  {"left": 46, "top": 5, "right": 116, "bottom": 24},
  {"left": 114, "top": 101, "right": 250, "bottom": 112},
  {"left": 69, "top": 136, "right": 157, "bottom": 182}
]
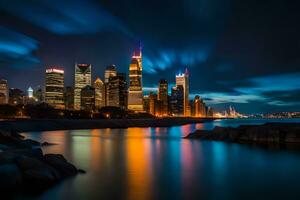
[{"left": 16, "top": 156, "right": 61, "bottom": 188}]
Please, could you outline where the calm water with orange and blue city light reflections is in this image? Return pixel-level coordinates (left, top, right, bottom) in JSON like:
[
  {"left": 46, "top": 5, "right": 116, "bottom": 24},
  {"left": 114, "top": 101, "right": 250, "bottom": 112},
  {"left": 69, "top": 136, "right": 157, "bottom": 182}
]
[{"left": 20, "top": 119, "right": 300, "bottom": 200}]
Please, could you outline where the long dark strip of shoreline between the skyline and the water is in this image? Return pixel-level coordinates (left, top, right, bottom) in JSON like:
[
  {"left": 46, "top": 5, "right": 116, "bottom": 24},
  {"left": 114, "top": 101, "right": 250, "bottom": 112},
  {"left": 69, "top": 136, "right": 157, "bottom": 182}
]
[{"left": 0, "top": 118, "right": 215, "bottom": 132}]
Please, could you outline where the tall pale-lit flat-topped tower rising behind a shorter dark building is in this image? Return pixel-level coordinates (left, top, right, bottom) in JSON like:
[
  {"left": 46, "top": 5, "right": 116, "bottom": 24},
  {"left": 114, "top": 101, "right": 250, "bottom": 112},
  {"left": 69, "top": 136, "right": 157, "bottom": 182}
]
[{"left": 74, "top": 64, "right": 92, "bottom": 110}]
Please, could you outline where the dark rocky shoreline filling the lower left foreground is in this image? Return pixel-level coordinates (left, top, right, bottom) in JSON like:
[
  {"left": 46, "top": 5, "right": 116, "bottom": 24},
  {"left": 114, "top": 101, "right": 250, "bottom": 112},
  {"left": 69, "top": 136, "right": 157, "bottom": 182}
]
[{"left": 0, "top": 129, "right": 82, "bottom": 193}]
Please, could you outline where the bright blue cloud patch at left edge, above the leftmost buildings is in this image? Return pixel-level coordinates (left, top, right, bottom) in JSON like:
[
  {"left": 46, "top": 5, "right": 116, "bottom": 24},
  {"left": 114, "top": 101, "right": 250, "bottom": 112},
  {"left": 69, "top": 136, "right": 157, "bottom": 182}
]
[{"left": 0, "top": 26, "right": 39, "bottom": 68}]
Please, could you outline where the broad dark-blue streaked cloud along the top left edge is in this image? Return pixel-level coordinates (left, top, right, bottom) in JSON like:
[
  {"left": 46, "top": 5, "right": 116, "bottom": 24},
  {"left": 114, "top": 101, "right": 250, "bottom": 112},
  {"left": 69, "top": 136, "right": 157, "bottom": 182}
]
[{"left": 0, "top": 0, "right": 129, "bottom": 35}]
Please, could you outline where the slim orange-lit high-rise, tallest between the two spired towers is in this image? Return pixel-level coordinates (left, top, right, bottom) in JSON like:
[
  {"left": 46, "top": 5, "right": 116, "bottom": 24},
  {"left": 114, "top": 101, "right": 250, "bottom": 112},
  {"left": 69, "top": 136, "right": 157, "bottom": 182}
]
[{"left": 157, "top": 79, "right": 168, "bottom": 116}]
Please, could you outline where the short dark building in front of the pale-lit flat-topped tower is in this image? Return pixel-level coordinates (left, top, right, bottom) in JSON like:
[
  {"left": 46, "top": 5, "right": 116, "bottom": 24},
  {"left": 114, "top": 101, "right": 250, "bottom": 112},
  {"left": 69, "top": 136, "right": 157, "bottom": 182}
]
[{"left": 80, "top": 85, "right": 95, "bottom": 111}]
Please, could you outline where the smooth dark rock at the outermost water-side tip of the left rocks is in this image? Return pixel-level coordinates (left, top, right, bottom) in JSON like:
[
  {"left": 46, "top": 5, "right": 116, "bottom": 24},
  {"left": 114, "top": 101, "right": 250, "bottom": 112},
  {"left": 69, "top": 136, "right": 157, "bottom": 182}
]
[{"left": 44, "top": 154, "right": 78, "bottom": 177}]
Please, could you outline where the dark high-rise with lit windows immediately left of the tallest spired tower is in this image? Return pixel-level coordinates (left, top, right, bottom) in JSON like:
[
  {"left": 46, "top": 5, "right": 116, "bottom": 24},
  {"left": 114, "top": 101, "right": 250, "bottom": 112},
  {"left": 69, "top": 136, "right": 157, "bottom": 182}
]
[{"left": 108, "top": 73, "right": 127, "bottom": 109}]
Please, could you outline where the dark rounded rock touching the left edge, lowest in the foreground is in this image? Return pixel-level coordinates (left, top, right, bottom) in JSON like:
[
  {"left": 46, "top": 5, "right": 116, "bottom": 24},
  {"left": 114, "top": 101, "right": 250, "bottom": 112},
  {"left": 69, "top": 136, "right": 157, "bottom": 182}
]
[{"left": 0, "top": 164, "right": 22, "bottom": 190}]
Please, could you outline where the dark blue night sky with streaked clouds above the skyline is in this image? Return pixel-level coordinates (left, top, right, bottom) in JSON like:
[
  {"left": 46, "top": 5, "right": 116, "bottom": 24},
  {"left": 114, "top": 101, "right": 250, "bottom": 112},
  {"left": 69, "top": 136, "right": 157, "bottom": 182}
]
[{"left": 0, "top": 0, "right": 300, "bottom": 113}]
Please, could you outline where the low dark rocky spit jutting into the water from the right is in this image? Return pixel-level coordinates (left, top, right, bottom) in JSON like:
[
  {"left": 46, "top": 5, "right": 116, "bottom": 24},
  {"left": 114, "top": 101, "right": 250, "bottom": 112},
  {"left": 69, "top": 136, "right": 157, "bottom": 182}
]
[{"left": 185, "top": 123, "right": 300, "bottom": 145}]
